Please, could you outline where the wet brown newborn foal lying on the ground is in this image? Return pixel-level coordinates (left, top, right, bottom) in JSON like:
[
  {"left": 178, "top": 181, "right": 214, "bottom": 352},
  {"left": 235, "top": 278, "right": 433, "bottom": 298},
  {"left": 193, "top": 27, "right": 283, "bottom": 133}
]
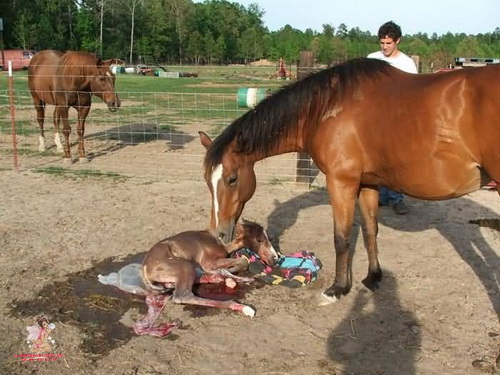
[{"left": 134, "top": 220, "right": 278, "bottom": 337}]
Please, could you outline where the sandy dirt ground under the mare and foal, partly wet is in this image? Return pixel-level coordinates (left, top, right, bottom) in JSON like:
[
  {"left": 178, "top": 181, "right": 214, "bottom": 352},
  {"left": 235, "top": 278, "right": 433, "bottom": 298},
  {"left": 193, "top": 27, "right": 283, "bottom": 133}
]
[{"left": 0, "top": 142, "right": 500, "bottom": 375}]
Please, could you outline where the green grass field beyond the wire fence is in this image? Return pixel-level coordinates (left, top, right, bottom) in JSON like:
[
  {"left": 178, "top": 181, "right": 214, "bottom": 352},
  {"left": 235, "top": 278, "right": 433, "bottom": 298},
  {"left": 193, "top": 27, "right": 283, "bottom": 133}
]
[{"left": 0, "top": 66, "right": 290, "bottom": 137}]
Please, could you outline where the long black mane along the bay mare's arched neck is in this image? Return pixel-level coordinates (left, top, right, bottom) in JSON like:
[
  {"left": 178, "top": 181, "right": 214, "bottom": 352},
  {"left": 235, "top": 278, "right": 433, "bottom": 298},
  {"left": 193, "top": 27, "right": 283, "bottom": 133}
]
[{"left": 205, "top": 58, "right": 390, "bottom": 172}]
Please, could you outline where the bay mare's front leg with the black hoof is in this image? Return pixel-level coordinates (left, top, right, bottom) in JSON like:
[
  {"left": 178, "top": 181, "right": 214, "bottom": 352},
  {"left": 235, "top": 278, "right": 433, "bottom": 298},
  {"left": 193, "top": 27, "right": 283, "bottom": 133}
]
[{"left": 359, "top": 187, "right": 382, "bottom": 290}]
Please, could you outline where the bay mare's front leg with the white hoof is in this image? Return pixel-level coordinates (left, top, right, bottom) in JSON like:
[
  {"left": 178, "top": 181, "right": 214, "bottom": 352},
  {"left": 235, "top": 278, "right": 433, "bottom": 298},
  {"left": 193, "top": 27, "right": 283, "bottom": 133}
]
[{"left": 321, "top": 177, "right": 359, "bottom": 304}]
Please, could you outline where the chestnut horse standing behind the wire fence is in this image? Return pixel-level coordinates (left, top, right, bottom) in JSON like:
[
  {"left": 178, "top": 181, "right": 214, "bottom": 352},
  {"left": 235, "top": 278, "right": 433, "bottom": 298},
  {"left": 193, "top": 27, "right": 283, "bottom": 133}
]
[{"left": 28, "top": 50, "right": 120, "bottom": 161}]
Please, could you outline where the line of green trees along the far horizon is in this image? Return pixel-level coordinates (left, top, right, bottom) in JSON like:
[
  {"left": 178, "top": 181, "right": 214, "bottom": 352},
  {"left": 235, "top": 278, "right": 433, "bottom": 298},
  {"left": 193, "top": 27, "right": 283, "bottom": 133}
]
[{"left": 0, "top": 0, "right": 500, "bottom": 71}]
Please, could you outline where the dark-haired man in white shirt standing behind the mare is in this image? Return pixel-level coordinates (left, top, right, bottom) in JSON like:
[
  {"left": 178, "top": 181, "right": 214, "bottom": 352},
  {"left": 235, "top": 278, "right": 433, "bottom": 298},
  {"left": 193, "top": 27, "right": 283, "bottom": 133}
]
[{"left": 368, "top": 21, "right": 418, "bottom": 215}]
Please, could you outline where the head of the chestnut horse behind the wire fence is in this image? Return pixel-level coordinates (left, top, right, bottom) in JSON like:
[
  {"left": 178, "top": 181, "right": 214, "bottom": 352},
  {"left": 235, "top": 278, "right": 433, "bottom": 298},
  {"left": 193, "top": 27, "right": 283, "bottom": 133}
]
[{"left": 90, "top": 59, "right": 121, "bottom": 112}]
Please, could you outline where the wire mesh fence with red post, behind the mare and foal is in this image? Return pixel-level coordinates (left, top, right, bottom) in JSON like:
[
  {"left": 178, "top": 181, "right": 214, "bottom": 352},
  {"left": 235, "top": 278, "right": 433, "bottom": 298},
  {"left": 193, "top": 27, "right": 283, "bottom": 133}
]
[{"left": 0, "top": 72, "right": 321, "bottom": 184}]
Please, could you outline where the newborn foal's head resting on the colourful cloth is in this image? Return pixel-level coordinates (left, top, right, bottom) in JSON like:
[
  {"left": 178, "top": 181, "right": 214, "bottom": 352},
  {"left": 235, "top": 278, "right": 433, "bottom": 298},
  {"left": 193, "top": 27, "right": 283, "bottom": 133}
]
[{"left": 233, "top": 219, "right": 278, "bottom": 266}]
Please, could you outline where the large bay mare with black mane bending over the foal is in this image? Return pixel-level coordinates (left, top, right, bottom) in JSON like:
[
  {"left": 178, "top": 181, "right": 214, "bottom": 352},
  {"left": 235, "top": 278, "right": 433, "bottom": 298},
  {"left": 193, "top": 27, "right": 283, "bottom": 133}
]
[{"left": 200, "top": 58, "right": 500, "bottom": 303}]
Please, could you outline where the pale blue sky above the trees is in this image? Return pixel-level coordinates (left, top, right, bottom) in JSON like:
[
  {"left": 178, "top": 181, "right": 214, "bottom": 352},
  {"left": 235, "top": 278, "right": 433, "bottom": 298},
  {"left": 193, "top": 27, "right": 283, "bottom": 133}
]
[{"left": 204, "top": 0, "right": 500, "bottom": 36}]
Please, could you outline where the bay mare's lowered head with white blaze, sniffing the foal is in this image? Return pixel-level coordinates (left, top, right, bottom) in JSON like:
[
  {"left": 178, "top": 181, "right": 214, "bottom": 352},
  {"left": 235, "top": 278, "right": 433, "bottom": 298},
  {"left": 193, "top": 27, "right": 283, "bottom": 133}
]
[{"left": 199, "top": 132, "right": 256, "bottom": 245}]
